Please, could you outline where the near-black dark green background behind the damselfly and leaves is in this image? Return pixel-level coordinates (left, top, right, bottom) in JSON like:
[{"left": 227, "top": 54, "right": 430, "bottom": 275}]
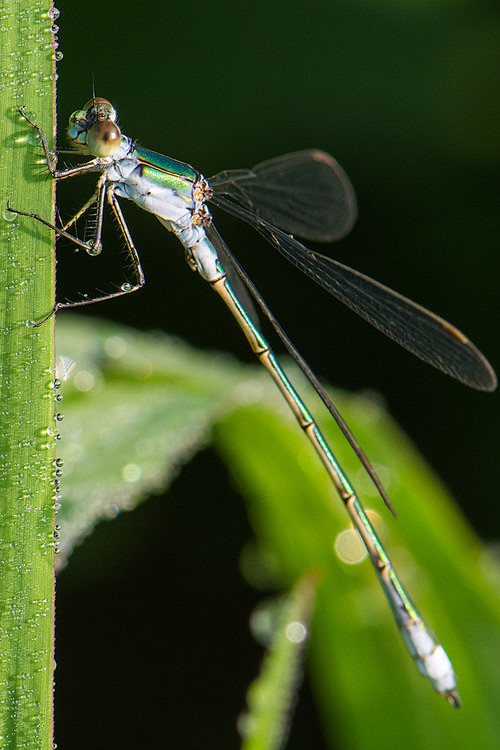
[{"left": 50, "top": 0, "right": 500, "bottom": 748}]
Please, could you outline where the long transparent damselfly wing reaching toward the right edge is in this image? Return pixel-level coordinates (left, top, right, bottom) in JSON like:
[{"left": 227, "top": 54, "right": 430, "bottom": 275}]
[{"left": 208, "top": 196, "right": 497, "bottom": 391}]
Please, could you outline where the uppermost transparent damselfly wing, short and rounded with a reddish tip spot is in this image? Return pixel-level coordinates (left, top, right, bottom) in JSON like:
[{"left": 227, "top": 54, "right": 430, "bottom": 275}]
[{"left": 209, "top": 149, "right": 357, "bottom": 242}]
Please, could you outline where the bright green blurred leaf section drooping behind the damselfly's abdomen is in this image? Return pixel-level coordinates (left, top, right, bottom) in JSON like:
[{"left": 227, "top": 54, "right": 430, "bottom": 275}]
[{"left": 216, "top": 393, "right": 500, "bottom": 750}]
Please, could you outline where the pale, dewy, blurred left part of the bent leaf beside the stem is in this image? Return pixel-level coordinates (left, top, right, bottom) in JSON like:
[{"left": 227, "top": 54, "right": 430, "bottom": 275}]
[{"left": 57, "top": 315, "right": 264, "bottom": 567}]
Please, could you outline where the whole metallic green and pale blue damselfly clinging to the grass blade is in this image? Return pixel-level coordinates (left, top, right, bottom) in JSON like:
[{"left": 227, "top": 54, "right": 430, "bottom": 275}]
[{"left": 10, "top": 97, "right": 496, "bottom": 707}]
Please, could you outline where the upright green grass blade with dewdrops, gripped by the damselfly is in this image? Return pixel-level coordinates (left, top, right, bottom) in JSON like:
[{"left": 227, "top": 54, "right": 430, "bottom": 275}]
[{"left": 0, "top": 0, "right": 55, "bottom": 750}]
